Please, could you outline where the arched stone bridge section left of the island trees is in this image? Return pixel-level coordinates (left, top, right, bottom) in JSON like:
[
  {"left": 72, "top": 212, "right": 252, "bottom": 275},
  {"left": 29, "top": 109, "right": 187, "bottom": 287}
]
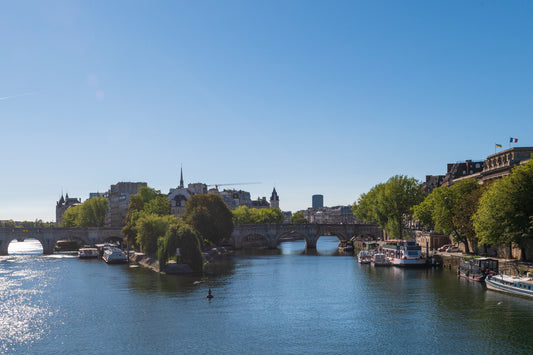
[{"left": 0, "top": 227, "right": 124, "bottom": 255}]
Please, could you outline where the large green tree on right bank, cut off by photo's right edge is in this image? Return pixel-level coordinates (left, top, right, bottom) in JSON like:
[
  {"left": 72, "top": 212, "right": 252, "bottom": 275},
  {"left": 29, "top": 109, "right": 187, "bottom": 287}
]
[{"left": 473, "top": 160, "right": 533, "bottom": 258}]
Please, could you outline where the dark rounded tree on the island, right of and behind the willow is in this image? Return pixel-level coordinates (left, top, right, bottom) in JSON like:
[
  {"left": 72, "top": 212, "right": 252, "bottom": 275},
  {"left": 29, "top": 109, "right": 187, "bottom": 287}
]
[{"left": 182, "top": 194, "right": 233, "bottom": 244}]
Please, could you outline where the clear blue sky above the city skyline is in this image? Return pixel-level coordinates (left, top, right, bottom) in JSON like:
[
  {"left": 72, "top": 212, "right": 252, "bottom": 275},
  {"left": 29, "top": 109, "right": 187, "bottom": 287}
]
[{"left": 0, "top": 0, "right": 533, "bottom": 221}]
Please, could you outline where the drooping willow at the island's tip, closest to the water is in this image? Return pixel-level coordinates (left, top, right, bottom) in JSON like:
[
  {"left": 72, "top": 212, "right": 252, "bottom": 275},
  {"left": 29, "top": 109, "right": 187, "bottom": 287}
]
[{"left": 158, "top": 220, "right": 204, "bottom": 272}]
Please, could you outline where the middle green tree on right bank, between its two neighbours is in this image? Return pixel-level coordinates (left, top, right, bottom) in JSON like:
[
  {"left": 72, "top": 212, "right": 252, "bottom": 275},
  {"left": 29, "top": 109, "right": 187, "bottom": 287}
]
[{"left": 413, "top": 179, "right": 480, "bottom": 252}]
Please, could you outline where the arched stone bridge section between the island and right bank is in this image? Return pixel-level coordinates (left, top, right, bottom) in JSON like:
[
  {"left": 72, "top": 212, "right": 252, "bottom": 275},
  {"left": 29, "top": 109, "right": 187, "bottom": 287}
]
[{"left": 231, "top": 224, "right": 383, "bottom": 249}]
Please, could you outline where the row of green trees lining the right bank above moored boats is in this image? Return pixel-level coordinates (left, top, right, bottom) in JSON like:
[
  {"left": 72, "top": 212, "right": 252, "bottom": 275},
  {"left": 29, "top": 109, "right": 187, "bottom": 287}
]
[{"left": 352, "top": 160, "right": 533, "bottom": 257}]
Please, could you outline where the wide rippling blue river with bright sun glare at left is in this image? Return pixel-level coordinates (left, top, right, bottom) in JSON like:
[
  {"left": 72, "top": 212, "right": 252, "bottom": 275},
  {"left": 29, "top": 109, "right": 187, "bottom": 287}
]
[{"left": 0, "top": 237, "right": 533, "bottom": 354}]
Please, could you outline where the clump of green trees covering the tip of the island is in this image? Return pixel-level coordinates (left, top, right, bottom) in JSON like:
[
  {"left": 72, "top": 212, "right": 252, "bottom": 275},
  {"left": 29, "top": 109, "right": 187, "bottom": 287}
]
[{"left": 122, "top": 187, "right": 233, "bottom": 271}]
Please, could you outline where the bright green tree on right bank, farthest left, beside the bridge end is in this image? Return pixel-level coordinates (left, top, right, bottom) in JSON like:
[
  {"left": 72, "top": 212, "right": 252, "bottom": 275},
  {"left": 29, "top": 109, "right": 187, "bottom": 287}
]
[{"left": 352, "top": 175, "right": 424, "bottom": 238}]
